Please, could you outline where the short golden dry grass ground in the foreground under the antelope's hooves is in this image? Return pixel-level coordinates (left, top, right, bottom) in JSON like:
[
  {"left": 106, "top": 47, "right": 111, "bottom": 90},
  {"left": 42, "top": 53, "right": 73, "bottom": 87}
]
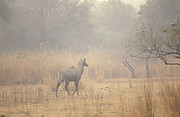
[{"left": 0, "top": 78, "right": 180, "bottom": 117}]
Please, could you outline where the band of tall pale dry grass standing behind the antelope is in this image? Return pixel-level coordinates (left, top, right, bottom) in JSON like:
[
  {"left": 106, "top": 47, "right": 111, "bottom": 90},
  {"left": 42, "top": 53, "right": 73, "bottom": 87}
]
[{"left": 0, "top": 50, "right": 179, "bottom": 85}]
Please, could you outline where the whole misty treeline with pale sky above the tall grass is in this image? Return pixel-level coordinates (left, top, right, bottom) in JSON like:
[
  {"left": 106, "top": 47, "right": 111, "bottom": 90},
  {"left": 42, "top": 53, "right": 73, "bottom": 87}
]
[{"left": 0, "top": 0, "right": 180, "bottom": 54}]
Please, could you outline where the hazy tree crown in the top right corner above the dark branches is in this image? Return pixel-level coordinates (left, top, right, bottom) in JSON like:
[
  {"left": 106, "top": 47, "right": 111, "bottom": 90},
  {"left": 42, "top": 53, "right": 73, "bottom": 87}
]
[{"left": 139, "top": 0, "right": 180, "bottom": 31}]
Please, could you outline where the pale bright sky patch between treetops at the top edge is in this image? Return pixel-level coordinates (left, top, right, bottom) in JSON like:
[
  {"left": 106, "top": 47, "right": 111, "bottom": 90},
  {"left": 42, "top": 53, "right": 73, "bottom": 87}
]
[{"left": 97, "top": 0, "right": 145, "bottom": 9}]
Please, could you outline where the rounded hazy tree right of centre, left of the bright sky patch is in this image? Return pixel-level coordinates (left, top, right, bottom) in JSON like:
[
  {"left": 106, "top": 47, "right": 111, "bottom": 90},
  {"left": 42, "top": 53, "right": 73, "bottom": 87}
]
[{"left": 93, "top": 0, "right": 136, "bottom": 52}]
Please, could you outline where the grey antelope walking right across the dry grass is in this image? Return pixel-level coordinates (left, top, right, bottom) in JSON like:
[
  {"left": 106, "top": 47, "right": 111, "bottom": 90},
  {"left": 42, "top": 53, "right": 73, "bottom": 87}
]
[{"left": 56, "top": 58, "right": 88, "bottom": 97}]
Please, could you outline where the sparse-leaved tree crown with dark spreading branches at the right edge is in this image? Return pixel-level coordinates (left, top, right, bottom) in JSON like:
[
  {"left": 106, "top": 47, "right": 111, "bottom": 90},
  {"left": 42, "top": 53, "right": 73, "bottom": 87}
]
[{"left": 128, "top": 19, "right": 180, "bottom": 65}]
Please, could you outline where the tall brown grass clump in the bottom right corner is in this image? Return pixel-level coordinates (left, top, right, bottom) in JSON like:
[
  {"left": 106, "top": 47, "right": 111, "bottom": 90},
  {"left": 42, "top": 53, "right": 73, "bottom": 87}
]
[{"left": 161, "top": 79, "right": 180, "bottom": 117}]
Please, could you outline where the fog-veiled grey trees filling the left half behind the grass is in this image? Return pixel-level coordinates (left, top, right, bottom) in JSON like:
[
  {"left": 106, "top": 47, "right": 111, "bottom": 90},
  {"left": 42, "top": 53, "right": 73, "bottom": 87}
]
[{"left": 0, "top": 0, "right": 93, "bottom": 51}]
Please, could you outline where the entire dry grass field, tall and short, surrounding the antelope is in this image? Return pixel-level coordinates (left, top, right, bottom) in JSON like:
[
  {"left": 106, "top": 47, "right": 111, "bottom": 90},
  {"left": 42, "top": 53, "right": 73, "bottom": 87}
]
[{"left": 0, "top": 51, "right": 180, "bottom": 117}]
